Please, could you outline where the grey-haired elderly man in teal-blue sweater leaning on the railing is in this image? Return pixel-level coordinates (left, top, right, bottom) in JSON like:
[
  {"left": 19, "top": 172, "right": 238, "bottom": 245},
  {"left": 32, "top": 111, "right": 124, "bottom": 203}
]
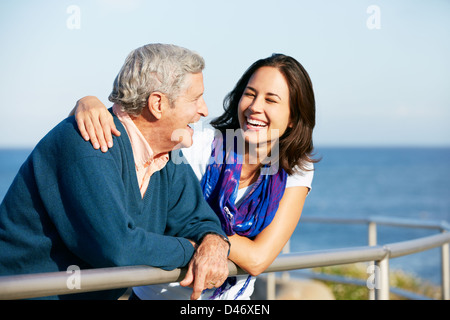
[{"left": 0, "top": 44, "right": 229, "bottom": 299}]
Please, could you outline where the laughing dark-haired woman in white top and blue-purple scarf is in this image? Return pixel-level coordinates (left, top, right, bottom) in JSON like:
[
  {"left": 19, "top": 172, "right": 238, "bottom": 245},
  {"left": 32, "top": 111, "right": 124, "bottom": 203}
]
[{"left": 76, "top": 54, "right": 317, "bottom": 299}]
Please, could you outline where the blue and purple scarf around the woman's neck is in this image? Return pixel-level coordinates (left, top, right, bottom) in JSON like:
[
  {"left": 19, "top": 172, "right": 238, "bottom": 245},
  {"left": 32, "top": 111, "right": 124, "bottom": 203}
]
[{"left": 201, "top": 132, "right": 287, "bottom": 298}]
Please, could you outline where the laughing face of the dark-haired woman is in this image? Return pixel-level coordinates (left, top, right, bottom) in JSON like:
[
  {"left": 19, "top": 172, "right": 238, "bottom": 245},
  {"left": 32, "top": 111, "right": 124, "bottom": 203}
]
[{"left": 238, "top": 67, "right": 291, "bottom": 145}]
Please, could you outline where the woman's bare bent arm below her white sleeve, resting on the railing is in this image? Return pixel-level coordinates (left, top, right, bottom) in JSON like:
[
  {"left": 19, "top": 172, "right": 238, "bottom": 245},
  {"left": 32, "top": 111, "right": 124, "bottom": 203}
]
[{"left": 228, "top": 187, "right": 308, "bottom": 276}]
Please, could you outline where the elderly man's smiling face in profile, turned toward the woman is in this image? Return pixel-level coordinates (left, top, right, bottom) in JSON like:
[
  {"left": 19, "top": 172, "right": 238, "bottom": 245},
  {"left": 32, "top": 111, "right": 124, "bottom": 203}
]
[{"left": 165, "top": 72, "right": 208, "bottom": 149}]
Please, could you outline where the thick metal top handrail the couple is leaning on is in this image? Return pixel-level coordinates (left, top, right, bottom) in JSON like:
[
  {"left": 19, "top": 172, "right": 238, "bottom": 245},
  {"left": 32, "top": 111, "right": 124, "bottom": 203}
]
[{"left": 0, "top": 232, "right": 450, "bottom": 299}]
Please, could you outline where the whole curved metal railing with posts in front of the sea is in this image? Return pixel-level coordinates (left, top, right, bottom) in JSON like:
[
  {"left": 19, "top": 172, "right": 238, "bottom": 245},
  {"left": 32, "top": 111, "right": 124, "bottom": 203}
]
[{"left": 0, "top": 217, "right": 450, "bottom": 300}]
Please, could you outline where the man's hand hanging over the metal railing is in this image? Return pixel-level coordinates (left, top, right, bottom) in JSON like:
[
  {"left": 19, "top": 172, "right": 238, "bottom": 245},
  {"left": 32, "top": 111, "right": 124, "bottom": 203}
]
[{"left": 180, "top": 234, "right": 229, "bottom": 300}]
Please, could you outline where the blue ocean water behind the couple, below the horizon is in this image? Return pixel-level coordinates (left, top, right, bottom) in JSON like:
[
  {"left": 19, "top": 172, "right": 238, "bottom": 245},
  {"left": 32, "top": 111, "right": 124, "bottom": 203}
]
[{"left": 0, "top": 147, "right": 450, "bottom": 283}]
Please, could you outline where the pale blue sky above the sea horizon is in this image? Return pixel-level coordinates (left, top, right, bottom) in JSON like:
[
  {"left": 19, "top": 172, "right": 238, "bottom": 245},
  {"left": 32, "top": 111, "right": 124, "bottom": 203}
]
[{"left": 0, "top": 0, "right": 450, "bottom": 147}]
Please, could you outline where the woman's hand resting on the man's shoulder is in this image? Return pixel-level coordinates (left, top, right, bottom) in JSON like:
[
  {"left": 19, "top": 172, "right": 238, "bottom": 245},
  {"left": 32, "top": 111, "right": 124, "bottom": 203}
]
[{"left": 69, "top": 96, "right": 120, "bottom": 152}]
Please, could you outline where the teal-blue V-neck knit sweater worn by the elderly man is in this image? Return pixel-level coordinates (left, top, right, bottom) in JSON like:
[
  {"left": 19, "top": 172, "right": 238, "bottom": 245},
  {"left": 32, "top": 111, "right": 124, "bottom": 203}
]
[{"left": 0, "top": 111, "right": 224, "bottom": 299}]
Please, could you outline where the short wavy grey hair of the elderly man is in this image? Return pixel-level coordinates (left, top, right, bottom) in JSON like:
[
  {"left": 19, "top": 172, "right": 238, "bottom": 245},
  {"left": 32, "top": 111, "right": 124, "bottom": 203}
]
[{"left": 109, "top": 43, "right": 205, "bottom": 116}]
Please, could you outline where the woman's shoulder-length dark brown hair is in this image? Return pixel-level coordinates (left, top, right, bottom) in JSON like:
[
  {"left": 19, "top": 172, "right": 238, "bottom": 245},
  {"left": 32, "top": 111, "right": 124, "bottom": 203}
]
[{"left": 211, "top": 54, "right": 318, "bottom": 175}]
